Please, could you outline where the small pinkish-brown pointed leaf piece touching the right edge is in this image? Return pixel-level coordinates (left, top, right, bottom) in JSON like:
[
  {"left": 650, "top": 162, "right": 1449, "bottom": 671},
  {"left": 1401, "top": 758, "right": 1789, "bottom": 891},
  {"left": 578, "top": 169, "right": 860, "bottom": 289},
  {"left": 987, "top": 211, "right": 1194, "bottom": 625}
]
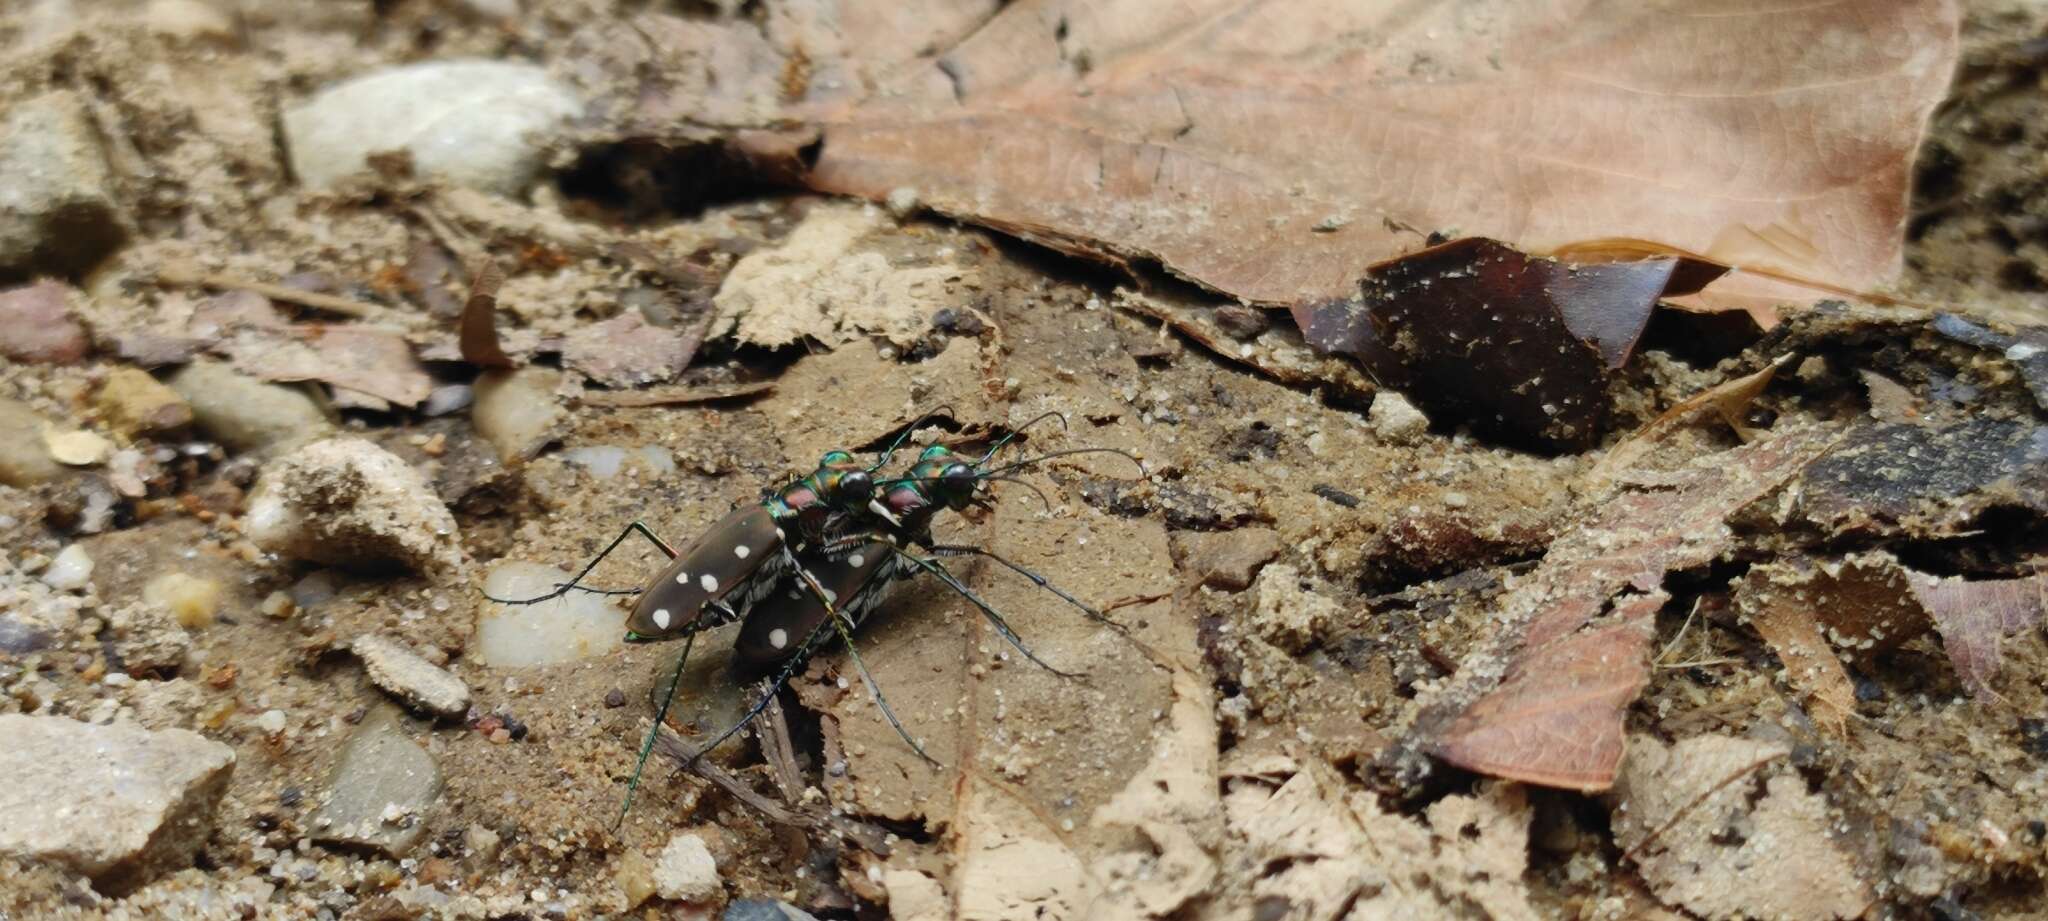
[{"left": 1911, "top": 573, "right": 2048, "bottom": 698}]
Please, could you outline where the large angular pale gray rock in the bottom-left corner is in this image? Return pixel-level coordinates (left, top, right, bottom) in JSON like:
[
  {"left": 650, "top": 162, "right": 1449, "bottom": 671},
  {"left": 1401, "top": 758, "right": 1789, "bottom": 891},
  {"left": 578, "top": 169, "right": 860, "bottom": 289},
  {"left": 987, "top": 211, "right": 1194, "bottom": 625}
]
[{"left": 0, "top": 714, "right": 236, "bottom": 894}]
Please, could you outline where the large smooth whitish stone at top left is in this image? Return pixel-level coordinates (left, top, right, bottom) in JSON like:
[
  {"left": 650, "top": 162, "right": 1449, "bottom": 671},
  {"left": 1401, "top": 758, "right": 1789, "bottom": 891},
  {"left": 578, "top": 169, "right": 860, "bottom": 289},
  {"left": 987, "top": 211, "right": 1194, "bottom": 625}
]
[{"left": 285, "top": 61, "right": 582, "bottom": 194}]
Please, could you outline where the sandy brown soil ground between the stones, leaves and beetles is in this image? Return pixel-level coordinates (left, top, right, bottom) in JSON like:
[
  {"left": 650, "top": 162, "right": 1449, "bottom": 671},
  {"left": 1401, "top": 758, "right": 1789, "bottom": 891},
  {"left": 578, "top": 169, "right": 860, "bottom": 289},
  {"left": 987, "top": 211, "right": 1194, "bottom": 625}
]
[{"left": 0, "top": 0, "right": 2048, "bottom": 919}]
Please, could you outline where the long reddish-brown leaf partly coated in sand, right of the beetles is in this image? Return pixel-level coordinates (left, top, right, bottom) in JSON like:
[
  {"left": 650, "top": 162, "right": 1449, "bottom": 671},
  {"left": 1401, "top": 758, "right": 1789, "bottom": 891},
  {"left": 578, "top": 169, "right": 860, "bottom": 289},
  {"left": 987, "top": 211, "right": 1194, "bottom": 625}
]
[{"left": 1380, "top": 426, "right": 1839, "bottom": 790}]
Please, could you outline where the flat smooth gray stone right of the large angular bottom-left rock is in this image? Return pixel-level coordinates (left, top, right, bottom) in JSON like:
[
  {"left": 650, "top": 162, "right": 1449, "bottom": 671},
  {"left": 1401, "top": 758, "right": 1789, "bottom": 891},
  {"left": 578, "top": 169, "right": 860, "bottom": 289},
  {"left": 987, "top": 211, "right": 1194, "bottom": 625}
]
[{"left": 313, "top": 706, "right": 440, "bottom": 858}]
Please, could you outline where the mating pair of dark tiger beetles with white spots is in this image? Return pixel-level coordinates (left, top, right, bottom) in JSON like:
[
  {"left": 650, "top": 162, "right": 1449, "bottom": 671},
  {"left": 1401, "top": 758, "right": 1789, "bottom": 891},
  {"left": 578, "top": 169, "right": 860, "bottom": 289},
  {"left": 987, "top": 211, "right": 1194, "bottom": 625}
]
[{"left": 492, "top": 413, "right": 1145, "bottom": 819}]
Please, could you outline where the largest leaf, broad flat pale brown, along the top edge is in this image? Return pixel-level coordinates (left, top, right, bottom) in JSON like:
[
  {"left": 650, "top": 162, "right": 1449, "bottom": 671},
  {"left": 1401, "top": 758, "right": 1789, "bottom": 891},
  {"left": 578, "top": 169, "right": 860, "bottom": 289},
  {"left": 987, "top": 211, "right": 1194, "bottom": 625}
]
[{"left": 778, "top": 0, "right": 1958, "bottom": 303}]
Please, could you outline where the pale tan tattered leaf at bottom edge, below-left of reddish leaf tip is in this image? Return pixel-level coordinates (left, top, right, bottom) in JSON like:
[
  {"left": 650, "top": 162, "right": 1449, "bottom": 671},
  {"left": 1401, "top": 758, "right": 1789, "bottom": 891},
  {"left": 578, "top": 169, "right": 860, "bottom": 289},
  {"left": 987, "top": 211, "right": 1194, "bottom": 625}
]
[{"left": 1223, "top": 759, "right": 1538, "bottom": 919}]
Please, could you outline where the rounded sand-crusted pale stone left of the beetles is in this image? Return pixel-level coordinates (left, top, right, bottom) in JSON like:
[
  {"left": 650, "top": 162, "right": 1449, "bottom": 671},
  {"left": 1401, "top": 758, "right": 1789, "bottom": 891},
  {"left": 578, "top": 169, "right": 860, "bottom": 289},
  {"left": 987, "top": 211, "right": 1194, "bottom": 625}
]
[{"left": 244, "top": 438, "right": 469, "bottom": 573}]
